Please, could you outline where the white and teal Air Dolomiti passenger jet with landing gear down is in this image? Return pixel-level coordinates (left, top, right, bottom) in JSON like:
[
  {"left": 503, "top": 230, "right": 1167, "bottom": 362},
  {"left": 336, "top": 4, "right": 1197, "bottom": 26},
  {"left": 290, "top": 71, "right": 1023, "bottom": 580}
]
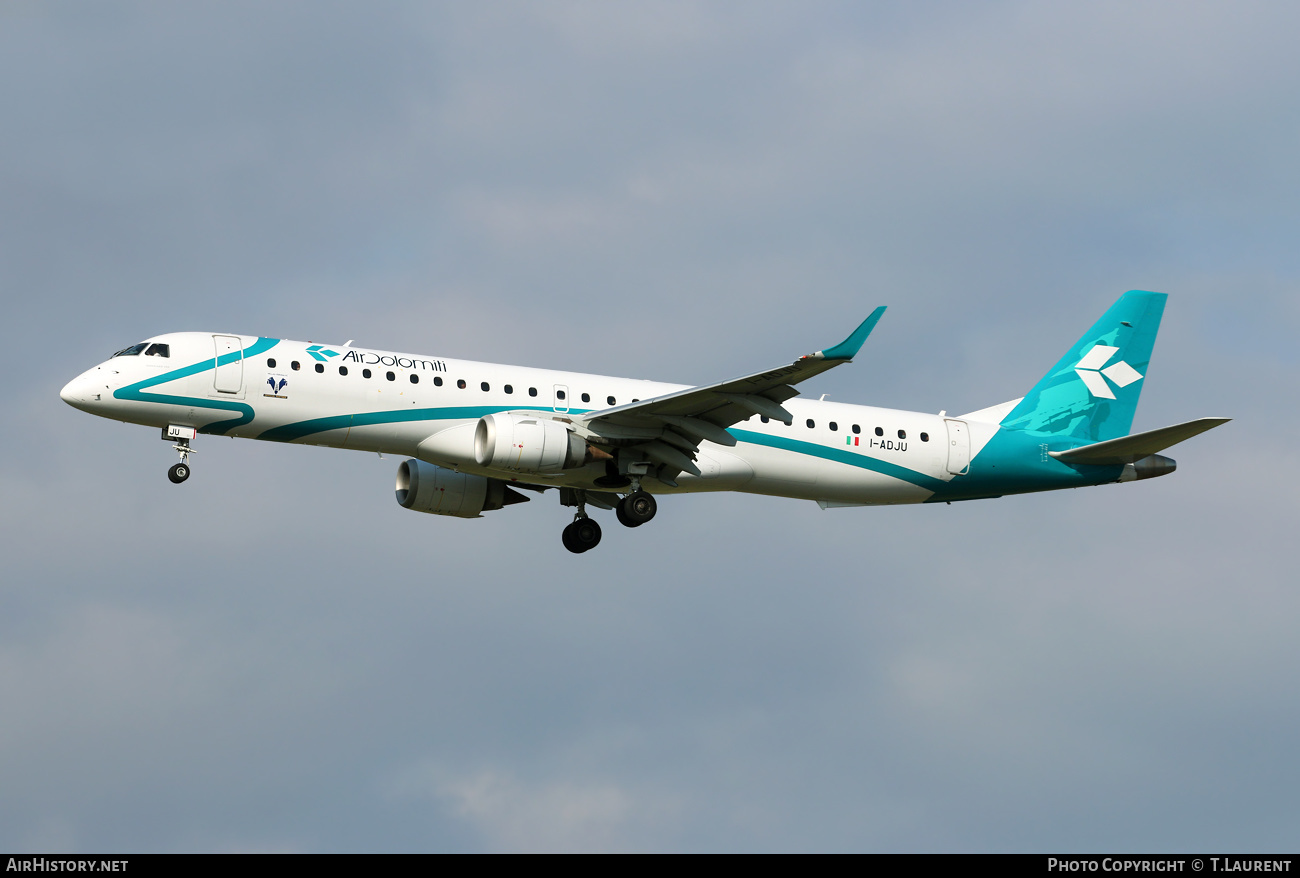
[{"left": 60, "top": 290, "right": 1230, "bottom": 553}]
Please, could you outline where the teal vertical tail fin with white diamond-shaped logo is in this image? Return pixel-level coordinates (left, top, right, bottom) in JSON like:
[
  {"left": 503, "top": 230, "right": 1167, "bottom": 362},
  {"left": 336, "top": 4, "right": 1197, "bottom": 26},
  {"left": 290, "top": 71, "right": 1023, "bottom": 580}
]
[{"left": 1002, "top": 290, "right": 1166, "bottom": 442}]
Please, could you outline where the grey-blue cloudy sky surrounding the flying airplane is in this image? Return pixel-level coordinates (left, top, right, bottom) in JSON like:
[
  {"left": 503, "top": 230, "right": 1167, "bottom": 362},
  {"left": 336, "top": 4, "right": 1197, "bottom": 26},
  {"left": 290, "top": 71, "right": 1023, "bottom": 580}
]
[{"left": 0, "top": 0, "right": 1300, "bottom": 852}]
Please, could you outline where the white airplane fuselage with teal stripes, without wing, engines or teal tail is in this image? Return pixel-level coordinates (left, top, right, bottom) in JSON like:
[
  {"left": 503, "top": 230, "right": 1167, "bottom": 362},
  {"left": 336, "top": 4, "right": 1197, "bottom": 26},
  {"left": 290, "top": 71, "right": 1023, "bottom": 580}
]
[{"left": 61, "top": 333, "right": 998, "bottom": 505}]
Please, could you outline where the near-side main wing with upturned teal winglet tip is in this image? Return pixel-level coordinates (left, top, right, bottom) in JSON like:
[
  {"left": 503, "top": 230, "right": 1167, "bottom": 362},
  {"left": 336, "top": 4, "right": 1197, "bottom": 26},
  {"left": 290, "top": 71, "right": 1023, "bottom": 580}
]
[{"left": 575, "top": 306, "right": 885, "bottom": 481}]
